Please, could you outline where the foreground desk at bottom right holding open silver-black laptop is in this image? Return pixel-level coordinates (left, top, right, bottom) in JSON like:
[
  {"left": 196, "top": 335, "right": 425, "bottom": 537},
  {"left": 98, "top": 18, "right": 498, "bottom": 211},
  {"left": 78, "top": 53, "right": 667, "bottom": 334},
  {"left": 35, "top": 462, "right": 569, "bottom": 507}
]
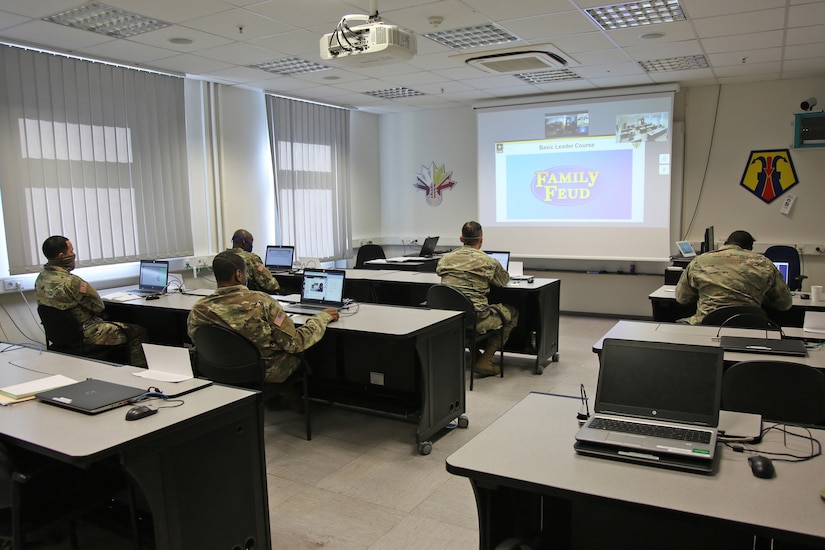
[{"left": 447, "top": 393, "right": 825, "bottom": 550}]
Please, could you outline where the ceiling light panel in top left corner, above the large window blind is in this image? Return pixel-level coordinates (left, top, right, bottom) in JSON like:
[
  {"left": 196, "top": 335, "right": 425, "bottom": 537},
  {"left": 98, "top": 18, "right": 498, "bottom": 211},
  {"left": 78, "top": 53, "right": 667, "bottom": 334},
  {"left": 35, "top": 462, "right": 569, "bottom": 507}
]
[{"left": 43, "top": 2, "right": 170, "bottom": 38}]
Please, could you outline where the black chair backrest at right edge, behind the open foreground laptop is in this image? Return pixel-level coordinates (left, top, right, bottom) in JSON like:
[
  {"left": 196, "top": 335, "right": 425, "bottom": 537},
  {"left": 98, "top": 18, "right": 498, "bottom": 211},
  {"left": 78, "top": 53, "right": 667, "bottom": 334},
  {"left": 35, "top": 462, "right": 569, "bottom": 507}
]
[{"left": 722, "top": 361, "right": 825, "bottom": 426}]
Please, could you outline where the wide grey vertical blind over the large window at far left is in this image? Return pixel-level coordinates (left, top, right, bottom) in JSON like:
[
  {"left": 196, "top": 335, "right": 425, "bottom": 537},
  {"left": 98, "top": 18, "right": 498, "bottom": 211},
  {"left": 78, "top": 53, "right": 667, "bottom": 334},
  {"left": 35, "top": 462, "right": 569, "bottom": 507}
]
[{"left": 0, "top": 46, "right": 193, "bottom": 275}]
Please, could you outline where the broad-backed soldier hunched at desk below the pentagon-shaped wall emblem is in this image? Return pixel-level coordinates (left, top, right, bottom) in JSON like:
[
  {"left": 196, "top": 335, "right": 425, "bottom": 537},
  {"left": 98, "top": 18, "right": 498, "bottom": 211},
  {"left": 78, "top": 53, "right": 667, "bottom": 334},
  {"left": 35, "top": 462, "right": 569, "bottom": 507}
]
[{"left": 676, "top": 230, "right": 793, "bottom": 325}]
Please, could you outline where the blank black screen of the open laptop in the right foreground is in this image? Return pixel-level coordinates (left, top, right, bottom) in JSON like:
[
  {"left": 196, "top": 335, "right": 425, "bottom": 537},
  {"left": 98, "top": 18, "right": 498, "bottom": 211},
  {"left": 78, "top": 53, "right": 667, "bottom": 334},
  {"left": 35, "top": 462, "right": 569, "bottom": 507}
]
[{"left": 594, "top": 338, "right": 724, "bottom": 427}]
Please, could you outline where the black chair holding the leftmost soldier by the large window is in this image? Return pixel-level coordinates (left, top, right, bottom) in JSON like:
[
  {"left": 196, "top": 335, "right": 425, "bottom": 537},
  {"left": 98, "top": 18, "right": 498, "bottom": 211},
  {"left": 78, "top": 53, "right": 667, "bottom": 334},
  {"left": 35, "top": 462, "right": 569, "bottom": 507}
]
[{"left": 37, "top": 304, "right": 129, "bottom": 364}]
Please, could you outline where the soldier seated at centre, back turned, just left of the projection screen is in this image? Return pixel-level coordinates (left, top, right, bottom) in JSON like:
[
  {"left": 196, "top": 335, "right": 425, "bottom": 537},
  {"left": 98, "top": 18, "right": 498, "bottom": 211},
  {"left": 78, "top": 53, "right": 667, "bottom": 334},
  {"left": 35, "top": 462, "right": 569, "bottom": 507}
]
[{"left": 436, "top": 221, "right": 518, "bottom": 376}]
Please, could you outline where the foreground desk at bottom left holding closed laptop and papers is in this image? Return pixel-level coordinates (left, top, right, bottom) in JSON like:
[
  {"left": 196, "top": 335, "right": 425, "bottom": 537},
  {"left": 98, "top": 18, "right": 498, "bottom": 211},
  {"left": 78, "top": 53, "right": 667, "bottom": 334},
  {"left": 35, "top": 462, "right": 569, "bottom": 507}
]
[{"left": 0, "top": 344, "right": 271, "bottom": 550}]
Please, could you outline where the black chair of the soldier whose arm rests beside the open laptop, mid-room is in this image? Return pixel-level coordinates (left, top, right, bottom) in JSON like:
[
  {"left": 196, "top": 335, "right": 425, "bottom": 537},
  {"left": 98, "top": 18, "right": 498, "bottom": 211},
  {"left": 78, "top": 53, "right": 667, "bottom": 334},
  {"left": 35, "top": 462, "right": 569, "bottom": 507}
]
[{"left": 194, "top": 325, "right": 312, "bottom": 441}]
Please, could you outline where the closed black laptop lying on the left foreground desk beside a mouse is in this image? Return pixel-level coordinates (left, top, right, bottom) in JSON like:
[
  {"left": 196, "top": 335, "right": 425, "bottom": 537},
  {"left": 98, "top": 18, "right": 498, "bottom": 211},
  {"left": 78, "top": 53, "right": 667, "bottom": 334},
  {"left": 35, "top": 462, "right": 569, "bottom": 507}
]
[{"left": 35, "top": 378, "right": 146, "bottom": 414}]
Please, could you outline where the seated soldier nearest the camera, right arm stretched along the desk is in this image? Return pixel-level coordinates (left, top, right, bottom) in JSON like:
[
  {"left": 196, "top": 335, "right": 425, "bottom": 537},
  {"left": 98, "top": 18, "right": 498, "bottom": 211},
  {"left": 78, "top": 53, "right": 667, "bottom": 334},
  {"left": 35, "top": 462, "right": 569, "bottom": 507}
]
[{"left": 187, "top": 250, "right": 338, "bottom": 383}]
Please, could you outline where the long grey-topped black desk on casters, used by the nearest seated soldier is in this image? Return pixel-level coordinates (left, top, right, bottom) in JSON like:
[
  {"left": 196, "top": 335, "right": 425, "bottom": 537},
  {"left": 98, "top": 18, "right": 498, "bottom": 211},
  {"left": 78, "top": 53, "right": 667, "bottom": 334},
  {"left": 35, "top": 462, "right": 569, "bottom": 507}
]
[{"left": 103, "top": 296, "right": 467, "bottom": 454}]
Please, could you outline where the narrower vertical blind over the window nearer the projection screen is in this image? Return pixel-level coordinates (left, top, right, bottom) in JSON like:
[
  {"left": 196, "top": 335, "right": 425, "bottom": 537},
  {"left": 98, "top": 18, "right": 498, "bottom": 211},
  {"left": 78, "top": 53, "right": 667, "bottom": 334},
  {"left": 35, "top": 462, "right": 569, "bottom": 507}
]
[{"left": 267, "top": 96, "right": 352, "bottom": 261}]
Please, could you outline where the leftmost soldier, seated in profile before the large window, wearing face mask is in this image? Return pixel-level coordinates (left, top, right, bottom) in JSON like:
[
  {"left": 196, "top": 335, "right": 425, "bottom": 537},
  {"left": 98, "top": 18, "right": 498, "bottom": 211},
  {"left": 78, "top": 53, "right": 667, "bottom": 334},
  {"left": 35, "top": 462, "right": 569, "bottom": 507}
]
[{"left": 34, "top": 235, "right": 147, "bottom": 367}]
